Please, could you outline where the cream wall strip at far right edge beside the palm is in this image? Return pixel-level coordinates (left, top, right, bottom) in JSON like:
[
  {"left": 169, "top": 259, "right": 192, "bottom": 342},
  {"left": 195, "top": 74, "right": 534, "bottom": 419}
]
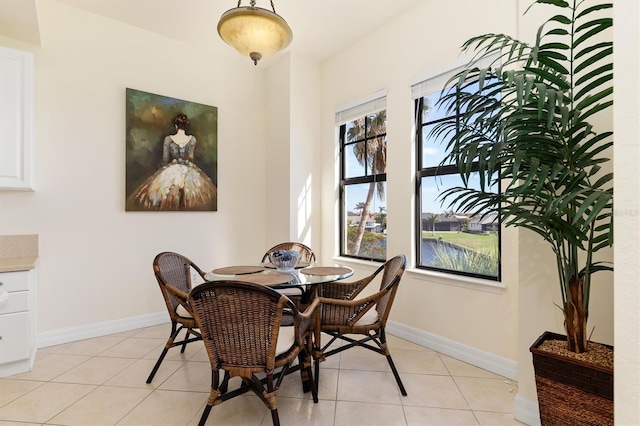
[{"left": 614, "top": 1, "right": 640, "bottom": 425}]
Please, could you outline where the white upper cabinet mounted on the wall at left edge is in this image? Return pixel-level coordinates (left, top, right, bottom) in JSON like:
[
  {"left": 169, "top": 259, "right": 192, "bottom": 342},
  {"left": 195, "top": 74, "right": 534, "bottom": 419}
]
[{"left": 0, "top": 46, "right": 34, "bottom": 190}]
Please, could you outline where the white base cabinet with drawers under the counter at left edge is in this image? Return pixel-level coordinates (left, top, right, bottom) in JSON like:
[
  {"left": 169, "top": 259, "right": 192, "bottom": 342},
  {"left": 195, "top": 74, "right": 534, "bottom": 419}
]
[{"left": 0, "top": 270, "right": 36, "bottom": 377}]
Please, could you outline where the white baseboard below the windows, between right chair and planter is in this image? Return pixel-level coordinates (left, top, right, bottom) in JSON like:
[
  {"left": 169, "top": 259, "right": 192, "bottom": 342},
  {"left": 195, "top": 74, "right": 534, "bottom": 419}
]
[{"left": 387, "top": 321, "right": 518, "bottom": 381}]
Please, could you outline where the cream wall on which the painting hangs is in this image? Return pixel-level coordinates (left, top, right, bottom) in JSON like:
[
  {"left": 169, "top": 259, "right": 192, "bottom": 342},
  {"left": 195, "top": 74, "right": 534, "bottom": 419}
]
[{"left": 0, "top": 1, "right": 266, "bottom": 334}]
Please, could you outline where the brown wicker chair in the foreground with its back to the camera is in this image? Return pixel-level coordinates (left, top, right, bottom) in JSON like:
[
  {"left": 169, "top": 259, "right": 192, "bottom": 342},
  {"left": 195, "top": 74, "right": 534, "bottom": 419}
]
[{"left": 188, "top": 280, "right": 318, "bottom": 426}]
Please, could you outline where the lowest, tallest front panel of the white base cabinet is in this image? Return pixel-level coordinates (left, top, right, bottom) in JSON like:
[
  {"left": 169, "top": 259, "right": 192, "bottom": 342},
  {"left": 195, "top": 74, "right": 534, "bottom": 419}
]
[{"left": 0, "top": 312, "right": 29, "bottom": 364}]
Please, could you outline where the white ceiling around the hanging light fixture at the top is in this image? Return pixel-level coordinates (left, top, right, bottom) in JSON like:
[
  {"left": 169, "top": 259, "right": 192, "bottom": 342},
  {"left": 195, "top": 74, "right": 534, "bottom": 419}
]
[{"left": 0, "top": 0, "right": 425, "bottom": 65}]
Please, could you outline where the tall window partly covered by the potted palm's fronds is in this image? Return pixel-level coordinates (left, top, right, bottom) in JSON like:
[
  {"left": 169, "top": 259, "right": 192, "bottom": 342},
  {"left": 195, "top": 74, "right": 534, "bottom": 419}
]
[{"left": 413, "top": 73, "right": 500, "bottom": 280}]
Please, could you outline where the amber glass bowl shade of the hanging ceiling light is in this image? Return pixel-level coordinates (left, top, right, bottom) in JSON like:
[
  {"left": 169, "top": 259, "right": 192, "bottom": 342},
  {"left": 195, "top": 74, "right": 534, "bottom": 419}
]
[{"left": 218, "top": 1, "right": 293, "bottom": 65}]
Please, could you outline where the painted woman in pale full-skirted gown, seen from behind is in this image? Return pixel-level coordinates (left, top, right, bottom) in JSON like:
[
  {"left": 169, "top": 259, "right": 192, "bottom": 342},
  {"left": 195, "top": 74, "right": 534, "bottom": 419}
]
[{"left": 126, "top": 89, "right": 217, "bottom": 211}]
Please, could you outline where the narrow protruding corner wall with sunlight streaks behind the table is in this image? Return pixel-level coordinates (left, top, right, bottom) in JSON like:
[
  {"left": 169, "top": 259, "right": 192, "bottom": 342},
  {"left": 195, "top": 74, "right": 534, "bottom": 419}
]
[{"left": 265, "top": 54, "right": 321, "bottom": 251}]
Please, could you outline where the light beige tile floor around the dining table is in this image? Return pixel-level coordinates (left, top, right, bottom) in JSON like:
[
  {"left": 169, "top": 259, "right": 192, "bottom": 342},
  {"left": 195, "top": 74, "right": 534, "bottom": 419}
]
[{"left": 0, "top": 324, "right": 521, "bottom": 426}]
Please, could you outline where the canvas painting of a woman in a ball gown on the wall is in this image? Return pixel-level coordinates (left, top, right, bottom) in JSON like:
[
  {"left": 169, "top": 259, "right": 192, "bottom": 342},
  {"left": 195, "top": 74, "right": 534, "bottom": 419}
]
[{"left": 125, "top": 88, "right": 218, "bottom": 211}]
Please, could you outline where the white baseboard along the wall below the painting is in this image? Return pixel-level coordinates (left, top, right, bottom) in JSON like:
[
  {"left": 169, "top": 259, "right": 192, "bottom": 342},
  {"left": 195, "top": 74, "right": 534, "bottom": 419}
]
[{"left": 37, "top": 310, "right": 169, "bottom": 348}]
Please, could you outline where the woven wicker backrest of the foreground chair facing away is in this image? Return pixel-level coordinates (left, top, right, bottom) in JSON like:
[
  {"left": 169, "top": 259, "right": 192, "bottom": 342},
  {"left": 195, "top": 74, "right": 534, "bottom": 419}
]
[{"left": 188, "top": 280, "right": 298, "bottom": 376}]
